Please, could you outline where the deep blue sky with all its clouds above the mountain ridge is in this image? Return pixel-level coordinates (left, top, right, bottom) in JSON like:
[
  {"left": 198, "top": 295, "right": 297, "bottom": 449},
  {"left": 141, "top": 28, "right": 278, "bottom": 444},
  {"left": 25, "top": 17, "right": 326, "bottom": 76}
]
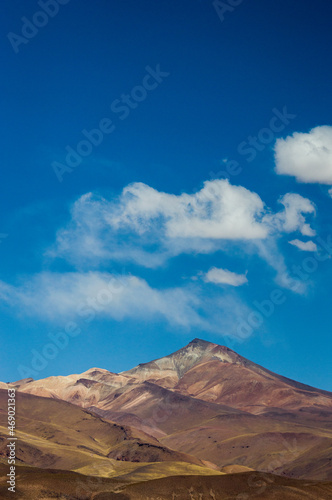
[{"left": 0, "top": 0, "right": 332, "bottom": 390}]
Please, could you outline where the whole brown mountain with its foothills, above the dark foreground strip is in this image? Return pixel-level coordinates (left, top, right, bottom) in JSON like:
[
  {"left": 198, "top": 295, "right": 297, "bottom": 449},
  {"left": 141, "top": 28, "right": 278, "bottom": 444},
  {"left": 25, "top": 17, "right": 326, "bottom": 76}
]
[{"left": 0, "top": 339, "right": 332, "bottom": 498}]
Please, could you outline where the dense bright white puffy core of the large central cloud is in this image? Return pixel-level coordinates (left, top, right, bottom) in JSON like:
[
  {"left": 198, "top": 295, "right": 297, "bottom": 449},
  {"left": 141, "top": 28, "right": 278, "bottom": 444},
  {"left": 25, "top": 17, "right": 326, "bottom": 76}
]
[{"left": 108, "top": 180, "right": 267, "bottom": 240}]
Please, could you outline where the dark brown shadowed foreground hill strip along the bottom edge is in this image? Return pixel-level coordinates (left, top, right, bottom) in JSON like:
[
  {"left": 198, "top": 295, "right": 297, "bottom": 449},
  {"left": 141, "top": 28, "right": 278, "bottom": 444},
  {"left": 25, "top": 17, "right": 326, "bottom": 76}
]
[{"left": 0, "top": 464, "right": 332, "bottom": 500}]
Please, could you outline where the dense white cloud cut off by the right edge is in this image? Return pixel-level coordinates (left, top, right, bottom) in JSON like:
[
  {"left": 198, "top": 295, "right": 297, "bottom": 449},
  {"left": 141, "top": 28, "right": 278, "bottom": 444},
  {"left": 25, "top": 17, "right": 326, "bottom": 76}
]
[{"left": 275, "top": 126, "right": 332, "bottom": 184}]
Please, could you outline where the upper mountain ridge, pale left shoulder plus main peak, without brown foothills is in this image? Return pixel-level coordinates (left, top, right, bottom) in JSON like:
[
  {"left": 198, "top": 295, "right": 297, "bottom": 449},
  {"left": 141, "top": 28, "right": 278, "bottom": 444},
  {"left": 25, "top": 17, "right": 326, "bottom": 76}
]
[{"left": 12, "top": 339, "right": 332, "bottom": 414}]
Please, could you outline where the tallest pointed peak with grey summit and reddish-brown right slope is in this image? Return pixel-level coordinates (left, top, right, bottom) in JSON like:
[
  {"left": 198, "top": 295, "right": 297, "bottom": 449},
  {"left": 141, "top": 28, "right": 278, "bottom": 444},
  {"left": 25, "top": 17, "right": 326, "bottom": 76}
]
[{"left": 122, "top": 339, "right": 332, "bottom": 413}]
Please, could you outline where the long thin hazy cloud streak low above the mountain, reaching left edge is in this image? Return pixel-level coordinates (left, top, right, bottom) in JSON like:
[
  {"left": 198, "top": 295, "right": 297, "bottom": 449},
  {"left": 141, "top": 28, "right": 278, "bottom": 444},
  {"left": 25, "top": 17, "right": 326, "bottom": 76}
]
[{"left": 0, "top": 272, "right": 249, "bottom": 334}]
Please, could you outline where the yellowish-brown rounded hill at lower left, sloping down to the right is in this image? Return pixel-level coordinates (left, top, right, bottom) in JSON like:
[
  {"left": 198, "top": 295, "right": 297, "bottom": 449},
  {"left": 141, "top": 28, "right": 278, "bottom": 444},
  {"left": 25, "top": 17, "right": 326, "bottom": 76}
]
[{"left": 0, "top": 390, "right": 208, "bottom": 475}]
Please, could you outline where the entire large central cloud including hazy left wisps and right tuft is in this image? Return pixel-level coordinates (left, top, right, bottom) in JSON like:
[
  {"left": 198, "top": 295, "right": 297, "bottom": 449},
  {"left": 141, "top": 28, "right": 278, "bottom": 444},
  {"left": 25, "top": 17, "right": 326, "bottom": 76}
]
[{"left": 48, "top": 179, "right": 314, "bottom": 274}]
